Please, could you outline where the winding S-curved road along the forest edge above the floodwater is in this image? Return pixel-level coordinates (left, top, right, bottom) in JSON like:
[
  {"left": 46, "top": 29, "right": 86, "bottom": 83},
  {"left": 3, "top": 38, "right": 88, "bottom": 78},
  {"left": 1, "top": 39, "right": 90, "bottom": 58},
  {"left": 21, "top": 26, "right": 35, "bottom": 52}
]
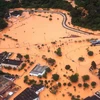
[{"left": 34, "top": 10, "right": 93, "bottom": 35}]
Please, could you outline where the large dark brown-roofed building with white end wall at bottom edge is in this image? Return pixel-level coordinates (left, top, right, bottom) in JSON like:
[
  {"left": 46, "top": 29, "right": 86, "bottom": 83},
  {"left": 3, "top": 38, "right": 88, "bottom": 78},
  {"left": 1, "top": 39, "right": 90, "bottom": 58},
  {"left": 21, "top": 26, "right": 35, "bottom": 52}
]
[{"left": 14, "top": 85, "right": 44, "bottom": 100}]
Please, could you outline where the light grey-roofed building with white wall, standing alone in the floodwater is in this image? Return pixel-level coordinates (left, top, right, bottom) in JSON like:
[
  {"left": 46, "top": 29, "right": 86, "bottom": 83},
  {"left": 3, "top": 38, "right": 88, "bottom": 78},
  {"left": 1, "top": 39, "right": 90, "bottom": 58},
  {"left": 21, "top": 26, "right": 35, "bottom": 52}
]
[{"left": 30, "top": 64, "right": 48, "bottom": 76}]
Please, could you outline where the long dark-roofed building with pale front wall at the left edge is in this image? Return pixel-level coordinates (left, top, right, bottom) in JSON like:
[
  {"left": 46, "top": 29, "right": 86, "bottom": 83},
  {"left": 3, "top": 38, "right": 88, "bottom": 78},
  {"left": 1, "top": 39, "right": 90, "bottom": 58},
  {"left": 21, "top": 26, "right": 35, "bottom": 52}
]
[{"left": 1, "top": 59, "right": 23, "bottom": 68}]
